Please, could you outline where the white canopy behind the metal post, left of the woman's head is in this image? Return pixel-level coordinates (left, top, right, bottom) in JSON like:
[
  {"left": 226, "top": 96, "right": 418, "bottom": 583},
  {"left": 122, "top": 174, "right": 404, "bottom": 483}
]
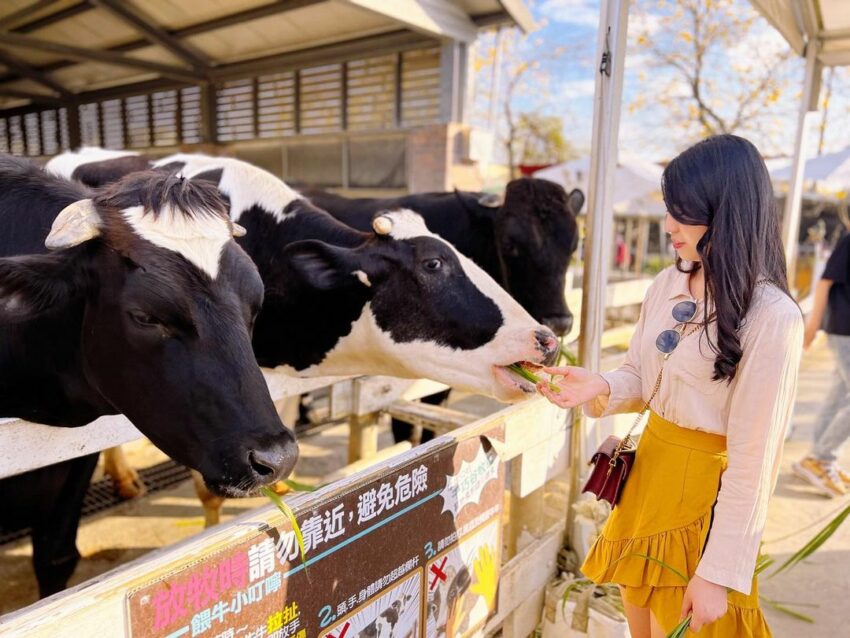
[{"left": 534, "top": 151, "right": 666, "bottom": 216}]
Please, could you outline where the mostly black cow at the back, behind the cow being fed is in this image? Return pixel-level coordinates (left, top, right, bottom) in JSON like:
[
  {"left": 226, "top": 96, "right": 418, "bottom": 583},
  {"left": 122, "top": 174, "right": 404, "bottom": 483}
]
[{"left": 299, "top": 177, "right": 584, "bottom": 335}]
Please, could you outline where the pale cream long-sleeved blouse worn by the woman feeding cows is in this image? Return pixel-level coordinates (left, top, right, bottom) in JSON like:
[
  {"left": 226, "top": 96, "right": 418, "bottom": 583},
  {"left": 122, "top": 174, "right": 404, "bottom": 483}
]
[{"left": 584, "top": 266, "right": 804, "bottom": 594}]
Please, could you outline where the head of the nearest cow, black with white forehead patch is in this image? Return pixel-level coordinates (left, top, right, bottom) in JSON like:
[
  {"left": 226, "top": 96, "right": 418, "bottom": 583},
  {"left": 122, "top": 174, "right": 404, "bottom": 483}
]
[{"left": 0, "top": 172, "right": 297, "bottom": 496}]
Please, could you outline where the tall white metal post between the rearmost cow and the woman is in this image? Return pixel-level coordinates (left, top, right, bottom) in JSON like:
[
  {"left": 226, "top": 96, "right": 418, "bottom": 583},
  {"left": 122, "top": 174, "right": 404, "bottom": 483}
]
[{"left": 567, "top": 0, "right": 629, "bottom": 536}]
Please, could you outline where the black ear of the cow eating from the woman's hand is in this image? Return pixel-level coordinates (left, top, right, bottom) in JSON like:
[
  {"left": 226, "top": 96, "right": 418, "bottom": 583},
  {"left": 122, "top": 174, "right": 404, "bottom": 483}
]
[{"left": 283, "top": 240, "right": 368, "bottom": 290}]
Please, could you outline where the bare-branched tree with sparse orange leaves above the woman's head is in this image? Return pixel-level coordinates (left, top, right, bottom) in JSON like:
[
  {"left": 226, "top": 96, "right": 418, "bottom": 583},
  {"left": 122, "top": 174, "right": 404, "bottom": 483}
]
[{"left": 627, "top": 0, "right": 796, "bottom": 152}]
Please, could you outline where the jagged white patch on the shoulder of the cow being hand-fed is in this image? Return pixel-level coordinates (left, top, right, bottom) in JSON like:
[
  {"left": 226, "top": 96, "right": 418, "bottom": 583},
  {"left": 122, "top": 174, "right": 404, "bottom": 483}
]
[{"left": 154, "top": 153, "right": 303, "bottom": 222}]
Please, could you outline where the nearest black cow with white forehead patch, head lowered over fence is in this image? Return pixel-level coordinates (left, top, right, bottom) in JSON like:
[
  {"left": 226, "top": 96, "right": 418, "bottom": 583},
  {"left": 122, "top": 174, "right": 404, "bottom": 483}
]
[{"left": 0, "top": 156, "right": 298, "bottom": 595}]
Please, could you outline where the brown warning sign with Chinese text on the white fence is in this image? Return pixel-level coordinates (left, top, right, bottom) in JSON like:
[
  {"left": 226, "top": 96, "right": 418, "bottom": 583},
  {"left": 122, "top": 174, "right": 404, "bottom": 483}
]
[{"left": 127, "top": 431, "right": 504, "bottom": 638}]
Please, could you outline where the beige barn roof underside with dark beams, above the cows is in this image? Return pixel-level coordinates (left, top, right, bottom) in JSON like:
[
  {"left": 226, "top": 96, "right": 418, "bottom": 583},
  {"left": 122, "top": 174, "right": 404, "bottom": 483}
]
[{"left": 0, "top": 0, "right": 533, "bottom": 109}]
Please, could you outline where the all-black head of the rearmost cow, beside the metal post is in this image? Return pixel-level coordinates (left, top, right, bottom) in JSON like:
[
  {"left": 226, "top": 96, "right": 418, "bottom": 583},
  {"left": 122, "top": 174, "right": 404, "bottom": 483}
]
[{"left": 496, "top": 177, "right": 584, "bottom": 335}]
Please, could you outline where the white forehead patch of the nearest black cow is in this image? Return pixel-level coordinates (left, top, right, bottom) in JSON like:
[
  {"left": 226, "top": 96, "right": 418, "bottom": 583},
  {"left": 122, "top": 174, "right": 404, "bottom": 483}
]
[{"left": 121, "top": 206, "right": 231, "bottom": 279}]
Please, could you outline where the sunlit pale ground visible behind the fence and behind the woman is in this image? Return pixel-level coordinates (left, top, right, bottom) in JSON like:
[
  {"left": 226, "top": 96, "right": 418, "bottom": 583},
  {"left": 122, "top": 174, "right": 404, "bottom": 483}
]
[{"left": 0, "top": 341, "right": 850, "bottom": 638}]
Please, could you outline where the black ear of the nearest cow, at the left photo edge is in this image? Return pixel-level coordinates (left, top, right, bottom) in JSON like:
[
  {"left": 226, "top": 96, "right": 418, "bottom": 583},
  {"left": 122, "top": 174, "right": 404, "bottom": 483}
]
[{"left": 0, "top": 253, "right": 78, "bottom": 324}]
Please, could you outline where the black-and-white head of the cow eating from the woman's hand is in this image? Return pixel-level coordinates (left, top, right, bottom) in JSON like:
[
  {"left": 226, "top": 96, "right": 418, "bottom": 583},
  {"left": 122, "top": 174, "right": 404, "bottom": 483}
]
[{"left": 274, "top": 210, "right": 558, "bottom": 401}]
